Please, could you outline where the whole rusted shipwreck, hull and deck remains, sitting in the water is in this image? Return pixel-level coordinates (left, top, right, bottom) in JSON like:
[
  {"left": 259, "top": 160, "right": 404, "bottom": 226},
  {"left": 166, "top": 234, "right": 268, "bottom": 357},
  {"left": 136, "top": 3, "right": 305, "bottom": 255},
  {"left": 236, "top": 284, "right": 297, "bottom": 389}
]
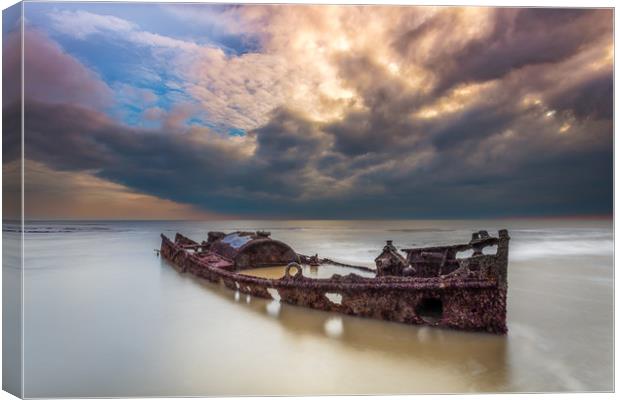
[{"left": 160, "top": 230, "right": 510, "bottom": 334}]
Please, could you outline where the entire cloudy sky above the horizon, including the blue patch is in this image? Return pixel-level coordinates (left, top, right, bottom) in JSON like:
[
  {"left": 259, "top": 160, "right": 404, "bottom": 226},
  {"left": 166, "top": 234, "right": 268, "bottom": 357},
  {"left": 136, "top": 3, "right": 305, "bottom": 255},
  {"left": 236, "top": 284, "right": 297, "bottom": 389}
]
[{"left": 3, "top": 2, "right": 614, "bottom": 219}]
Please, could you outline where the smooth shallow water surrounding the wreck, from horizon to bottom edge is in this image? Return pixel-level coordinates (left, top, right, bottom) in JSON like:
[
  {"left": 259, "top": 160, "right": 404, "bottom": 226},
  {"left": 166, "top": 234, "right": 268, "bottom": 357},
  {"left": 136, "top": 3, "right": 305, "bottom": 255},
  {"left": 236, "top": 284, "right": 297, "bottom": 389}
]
[{"left": 3, "top": 220, "right": 613, "bottom": 397}]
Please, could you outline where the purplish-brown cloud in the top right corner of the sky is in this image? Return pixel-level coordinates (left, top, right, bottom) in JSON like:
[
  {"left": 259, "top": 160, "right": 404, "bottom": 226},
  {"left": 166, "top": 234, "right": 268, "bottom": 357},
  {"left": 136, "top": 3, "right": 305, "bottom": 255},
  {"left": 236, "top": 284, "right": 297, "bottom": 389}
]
[{"left": 393, "top": 8, "right": 613, "bottom": 93}]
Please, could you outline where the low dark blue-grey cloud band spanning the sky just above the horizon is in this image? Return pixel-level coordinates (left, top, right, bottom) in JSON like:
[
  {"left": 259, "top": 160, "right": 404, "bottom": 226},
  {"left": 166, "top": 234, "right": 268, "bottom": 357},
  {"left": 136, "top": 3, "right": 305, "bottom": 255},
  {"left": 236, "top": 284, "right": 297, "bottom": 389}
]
[{"left": 17, "top": 88, "right": 612, "bottom": 218}]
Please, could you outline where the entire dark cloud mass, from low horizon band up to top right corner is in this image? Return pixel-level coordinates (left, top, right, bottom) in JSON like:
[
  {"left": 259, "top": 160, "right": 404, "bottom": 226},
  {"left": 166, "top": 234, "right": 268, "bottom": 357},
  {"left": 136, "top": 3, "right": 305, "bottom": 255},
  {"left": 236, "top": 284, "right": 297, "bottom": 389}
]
[{"left": 10, "top": 9, "right": 613, "bottom": 218}]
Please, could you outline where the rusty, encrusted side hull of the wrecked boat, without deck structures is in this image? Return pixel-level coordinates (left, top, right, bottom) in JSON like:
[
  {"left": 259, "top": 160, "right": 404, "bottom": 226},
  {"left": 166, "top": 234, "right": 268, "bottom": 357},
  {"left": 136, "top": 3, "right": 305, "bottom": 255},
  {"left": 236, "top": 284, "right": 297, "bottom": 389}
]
[{"left": 160, "top": 234, "right": 507, "bottom": 334}]
